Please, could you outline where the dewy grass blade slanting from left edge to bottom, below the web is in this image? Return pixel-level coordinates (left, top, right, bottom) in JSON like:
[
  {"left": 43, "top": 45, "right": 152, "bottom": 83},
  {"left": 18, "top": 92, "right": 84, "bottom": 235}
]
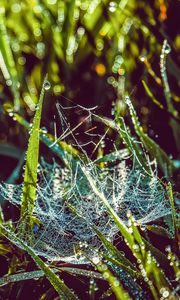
[{"left": 0, "top": 224, "right": 78, "bottom": 300}]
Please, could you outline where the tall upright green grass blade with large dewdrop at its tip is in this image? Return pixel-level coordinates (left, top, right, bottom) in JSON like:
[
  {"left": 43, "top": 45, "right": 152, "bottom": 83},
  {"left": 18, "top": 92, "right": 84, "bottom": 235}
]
[{"left": 19, "top": 76, "right": 47, "bottom": 236}]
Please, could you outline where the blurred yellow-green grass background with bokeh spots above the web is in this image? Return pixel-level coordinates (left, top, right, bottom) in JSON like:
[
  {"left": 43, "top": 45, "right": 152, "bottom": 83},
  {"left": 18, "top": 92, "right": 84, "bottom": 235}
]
[{"left": 0, "top": 0, "right": 180, "bottom": 180}]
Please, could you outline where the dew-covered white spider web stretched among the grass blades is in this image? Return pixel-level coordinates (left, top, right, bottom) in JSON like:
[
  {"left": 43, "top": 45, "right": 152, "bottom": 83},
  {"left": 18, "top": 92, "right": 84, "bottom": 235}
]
[{"left": 0, "top": 100, "right": 170, "bottom": 263}]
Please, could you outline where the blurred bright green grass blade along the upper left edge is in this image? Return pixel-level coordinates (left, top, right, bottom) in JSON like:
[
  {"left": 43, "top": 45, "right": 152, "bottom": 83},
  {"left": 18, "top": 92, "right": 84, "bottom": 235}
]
[{"left": 0, "top": 9, "right": 20, "bottom": 111}]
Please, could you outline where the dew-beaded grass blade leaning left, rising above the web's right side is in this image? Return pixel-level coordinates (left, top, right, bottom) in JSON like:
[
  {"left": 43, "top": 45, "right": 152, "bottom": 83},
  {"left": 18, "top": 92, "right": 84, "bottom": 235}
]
[{"left": 126, "top": 97, "right": 174, "bottom": 177}]
